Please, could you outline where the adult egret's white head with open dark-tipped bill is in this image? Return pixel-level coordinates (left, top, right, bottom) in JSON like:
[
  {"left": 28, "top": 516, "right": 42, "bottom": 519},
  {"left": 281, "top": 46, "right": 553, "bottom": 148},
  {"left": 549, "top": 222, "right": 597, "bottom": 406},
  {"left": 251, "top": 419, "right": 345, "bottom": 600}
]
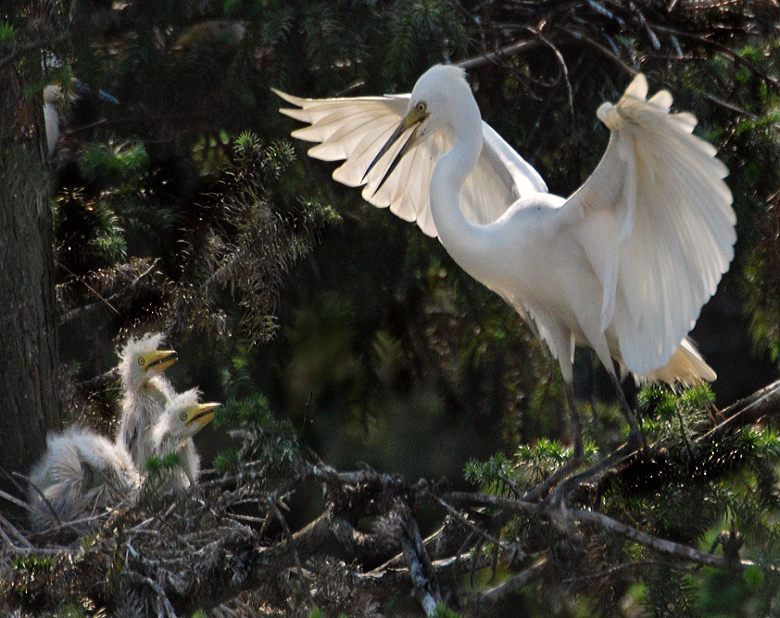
[{"left": 363, "top": 64, "right": 481, "bottom": 191}]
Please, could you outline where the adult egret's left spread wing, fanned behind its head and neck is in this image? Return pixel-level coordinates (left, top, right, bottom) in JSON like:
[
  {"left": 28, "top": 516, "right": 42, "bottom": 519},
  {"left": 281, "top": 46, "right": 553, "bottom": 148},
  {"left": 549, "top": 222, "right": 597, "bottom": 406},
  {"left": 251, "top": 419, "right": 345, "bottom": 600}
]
[{"left": 274, "top": 90, "right": 547, "bottom": 236}]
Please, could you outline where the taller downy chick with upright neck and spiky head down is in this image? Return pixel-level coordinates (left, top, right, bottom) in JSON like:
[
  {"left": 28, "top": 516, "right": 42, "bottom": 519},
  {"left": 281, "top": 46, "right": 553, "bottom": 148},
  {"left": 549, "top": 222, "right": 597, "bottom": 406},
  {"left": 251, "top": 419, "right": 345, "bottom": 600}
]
[{"left": 116, "top": 333, "right": 177, "bottom": 470}]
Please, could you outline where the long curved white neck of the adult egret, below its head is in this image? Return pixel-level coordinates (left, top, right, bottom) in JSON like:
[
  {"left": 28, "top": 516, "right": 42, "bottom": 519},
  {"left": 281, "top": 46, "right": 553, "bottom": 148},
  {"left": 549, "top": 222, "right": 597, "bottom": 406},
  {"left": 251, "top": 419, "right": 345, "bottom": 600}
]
[{"left": 430, "top": 112, "right": 489, "bottom": 279}]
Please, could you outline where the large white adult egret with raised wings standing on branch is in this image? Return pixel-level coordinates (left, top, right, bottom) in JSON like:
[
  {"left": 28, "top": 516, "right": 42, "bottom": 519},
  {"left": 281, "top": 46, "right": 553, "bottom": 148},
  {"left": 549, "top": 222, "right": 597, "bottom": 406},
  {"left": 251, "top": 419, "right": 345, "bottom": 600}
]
[{"left": 275, "top": 65, "right": 736, "bottom": 450}]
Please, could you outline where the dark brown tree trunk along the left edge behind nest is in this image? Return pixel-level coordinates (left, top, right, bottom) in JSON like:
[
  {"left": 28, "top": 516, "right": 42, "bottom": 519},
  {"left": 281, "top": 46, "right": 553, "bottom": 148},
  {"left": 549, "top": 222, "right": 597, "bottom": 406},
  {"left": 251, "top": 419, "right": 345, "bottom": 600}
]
[{"left": 0, "top": 43, "right": 60, "bottom": 484}]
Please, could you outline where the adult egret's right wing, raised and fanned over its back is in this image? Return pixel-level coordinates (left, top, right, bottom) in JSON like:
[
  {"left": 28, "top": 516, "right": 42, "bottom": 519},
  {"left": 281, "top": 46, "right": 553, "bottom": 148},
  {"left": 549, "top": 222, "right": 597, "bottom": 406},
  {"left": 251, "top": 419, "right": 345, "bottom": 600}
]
[{"left": 560, "top": 74, "right": 736, "bottom": 375}]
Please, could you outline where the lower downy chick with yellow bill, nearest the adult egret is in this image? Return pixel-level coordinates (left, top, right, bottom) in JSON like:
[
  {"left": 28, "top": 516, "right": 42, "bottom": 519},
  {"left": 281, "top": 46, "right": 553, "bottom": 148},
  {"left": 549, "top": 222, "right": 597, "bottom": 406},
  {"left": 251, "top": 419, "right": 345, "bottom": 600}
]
[{"left": 149, "top": 388, "right": 220, "bottom": 491}]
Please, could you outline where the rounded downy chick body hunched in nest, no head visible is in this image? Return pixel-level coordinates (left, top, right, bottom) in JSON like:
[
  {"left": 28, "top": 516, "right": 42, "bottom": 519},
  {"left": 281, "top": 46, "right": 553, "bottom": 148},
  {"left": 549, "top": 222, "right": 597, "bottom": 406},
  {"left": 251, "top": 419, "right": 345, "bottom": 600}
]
[{"left": 28, "top": 428, "right": 141, "bottom": 531}]
